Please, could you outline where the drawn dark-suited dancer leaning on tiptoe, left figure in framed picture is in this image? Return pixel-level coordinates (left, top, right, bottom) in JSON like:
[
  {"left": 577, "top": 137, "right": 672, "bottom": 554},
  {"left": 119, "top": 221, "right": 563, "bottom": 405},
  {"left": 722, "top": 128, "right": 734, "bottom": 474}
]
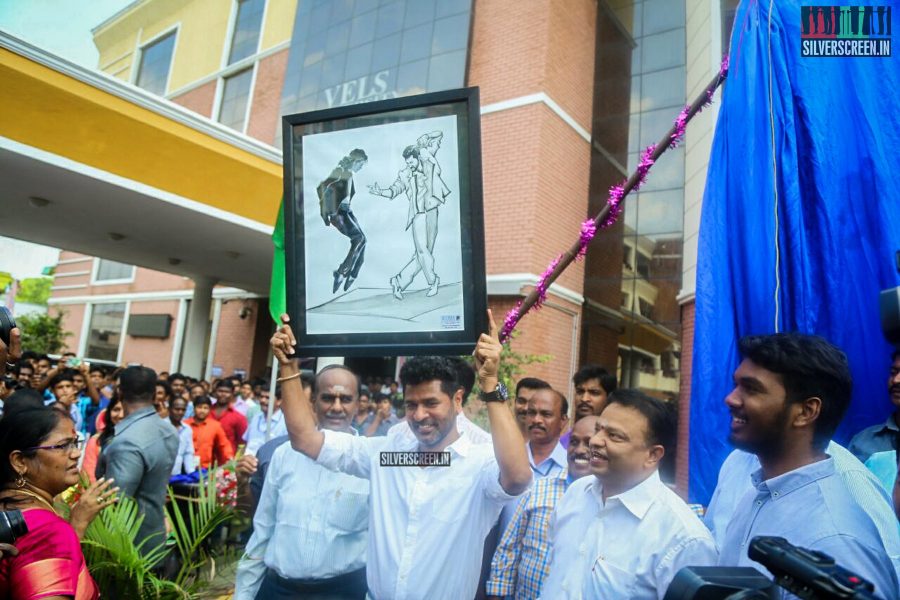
[{"left": 316, "top": 148, "right": 369, "bottom": 293}]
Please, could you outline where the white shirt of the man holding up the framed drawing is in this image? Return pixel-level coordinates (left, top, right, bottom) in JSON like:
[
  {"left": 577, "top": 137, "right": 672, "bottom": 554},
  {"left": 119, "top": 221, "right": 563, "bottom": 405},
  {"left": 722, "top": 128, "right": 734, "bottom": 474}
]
[{"left": 318, "top": 431, "right": 532, "bottom": 600}]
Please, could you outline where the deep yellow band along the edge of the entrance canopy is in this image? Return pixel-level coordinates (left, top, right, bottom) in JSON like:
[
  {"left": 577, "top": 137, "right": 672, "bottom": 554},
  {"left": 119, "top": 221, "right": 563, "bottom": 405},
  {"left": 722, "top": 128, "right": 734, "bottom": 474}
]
[{"left": 0, "top": 49, "right": 282, "bottom": 225}]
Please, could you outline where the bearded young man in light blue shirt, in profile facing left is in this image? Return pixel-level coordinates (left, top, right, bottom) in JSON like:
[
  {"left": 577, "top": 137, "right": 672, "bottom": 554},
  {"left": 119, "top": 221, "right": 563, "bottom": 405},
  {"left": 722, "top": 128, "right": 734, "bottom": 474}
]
[{"left": 719, "top": 333, "right": 898, "bottom": 596}]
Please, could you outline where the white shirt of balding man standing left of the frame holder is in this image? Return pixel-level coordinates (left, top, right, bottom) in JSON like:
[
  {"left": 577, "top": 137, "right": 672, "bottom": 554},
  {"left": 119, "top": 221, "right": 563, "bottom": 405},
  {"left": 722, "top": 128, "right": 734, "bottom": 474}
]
[{"left": 234, "top": 443, "right": 369, "bottom": 600}]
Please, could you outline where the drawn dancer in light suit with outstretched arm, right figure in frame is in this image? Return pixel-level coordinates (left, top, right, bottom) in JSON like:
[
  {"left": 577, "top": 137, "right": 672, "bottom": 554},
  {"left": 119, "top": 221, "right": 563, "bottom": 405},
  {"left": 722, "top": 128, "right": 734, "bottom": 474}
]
[{"left": 369, "top": 131, "right": 450, "bottom": 300}]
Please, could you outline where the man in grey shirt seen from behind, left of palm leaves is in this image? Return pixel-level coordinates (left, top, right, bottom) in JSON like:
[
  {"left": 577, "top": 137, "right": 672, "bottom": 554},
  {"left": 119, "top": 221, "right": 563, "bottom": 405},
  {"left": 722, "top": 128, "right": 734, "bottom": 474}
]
[{"left": 97, "top": 367, "right": 178, "bottom": 554}]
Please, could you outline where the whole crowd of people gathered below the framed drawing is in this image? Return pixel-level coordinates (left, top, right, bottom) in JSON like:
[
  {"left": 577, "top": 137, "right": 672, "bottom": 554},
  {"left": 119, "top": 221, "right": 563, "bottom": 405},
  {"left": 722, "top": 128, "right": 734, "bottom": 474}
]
[{"left": 0, "top": 315, "right": 900, "bottom": 600}]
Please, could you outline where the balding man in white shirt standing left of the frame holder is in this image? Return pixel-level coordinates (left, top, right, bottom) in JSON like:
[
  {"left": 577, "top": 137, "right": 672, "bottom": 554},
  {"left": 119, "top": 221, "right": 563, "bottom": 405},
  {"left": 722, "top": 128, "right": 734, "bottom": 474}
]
[{"left": 234, "top": 365, "right": 369, "bottom": 600}]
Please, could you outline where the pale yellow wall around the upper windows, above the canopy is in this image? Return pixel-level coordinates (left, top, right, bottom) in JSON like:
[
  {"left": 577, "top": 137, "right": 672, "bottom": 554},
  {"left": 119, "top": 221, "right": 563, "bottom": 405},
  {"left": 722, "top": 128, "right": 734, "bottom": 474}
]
[{"left": 94, "top": 0, "right": 297, "bottom": 93}]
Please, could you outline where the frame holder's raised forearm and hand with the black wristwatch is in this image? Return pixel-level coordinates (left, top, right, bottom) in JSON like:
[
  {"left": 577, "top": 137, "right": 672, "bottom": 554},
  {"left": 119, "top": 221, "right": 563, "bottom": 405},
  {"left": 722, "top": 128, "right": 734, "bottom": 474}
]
[{"left": 473, "top": 310, "right": 531, "bottom": 496}]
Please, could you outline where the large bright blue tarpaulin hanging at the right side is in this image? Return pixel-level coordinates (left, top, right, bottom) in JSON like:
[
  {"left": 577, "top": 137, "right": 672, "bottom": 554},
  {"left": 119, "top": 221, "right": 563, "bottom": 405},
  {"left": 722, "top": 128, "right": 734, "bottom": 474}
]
[{"left": 690, "top": 0, "right": 900, "bottom": 504}]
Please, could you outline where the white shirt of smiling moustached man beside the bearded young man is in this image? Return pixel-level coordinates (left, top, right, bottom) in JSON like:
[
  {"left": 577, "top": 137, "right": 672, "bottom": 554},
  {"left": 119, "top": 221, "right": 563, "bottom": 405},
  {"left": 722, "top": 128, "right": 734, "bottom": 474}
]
[{"left": 541, "top": 472, "right": 717, "bottom": 600}]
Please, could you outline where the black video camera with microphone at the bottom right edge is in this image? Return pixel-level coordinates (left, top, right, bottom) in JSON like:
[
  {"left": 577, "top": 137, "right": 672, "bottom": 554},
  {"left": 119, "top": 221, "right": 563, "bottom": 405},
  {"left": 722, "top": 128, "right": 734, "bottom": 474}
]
[{"left": 664, "top": 536, "right": 875, "bottom": 600}]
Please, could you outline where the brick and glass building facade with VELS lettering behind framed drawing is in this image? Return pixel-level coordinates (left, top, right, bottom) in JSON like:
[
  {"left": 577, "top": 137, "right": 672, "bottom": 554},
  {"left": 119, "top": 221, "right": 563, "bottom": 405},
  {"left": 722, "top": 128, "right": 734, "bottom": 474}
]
[{"left": 42, "top": 0, "right": 735, "bottom": 486}]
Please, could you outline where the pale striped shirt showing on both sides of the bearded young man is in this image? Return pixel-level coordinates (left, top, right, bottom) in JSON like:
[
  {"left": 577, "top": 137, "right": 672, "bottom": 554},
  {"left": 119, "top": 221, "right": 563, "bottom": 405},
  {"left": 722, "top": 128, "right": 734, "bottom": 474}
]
[{"left": 703, "top": 441, "right": 900, "bottom": 580}]
